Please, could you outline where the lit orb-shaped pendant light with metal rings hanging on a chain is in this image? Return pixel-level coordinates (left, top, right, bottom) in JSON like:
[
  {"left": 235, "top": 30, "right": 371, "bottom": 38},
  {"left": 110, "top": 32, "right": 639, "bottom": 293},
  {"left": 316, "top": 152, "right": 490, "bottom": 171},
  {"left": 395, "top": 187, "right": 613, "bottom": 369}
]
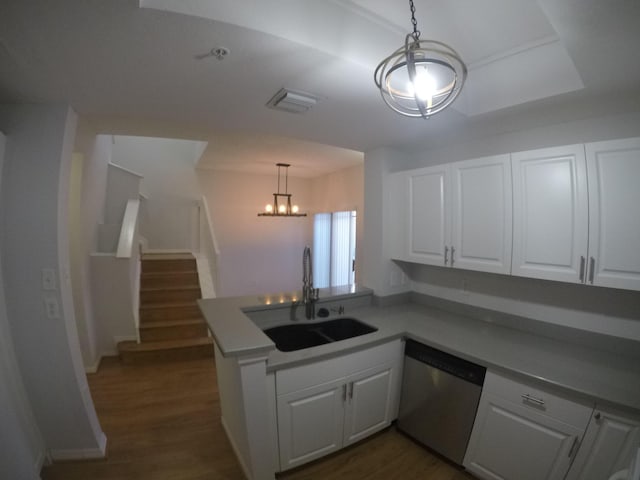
[{"left": 374, "top": 0, "right": 467, "bottom": 118}]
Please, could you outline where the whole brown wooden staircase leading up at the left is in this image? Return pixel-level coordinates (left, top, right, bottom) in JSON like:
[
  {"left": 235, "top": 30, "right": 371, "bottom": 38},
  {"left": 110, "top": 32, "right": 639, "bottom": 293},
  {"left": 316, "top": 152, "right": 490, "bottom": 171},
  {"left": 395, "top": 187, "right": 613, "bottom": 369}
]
[{"left": 118, "top": 254, "right": 213, "bottom": 364}]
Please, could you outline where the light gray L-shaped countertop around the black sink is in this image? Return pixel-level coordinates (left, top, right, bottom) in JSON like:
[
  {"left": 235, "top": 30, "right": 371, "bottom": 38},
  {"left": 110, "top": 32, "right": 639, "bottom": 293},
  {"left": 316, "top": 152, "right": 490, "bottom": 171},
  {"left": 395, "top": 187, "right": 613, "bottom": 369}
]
[{"left": 199, "top": 289, "right": 640, "bottom": 410}]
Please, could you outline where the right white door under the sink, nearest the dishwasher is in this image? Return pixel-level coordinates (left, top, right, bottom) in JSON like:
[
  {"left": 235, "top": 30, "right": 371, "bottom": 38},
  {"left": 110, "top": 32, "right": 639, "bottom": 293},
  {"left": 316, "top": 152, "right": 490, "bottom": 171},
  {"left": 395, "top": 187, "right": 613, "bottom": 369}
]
[{"left": 344, "top": 363, "right": 395, "bottom": 446}]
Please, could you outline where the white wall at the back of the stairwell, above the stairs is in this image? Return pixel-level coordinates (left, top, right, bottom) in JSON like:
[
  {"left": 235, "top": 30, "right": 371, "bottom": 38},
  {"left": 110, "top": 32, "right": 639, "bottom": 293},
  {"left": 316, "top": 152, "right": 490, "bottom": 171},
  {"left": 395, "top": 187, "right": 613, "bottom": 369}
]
[{"left": 112, "top": 136, "right": 206, "bottom": 250}]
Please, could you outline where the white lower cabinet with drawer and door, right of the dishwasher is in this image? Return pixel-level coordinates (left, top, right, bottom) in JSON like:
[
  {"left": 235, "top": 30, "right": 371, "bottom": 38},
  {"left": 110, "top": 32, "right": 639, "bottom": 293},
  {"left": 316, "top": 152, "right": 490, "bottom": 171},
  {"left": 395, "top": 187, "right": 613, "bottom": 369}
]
[{"left": 464, "top": 372, "right": 593, "bottom": 480}]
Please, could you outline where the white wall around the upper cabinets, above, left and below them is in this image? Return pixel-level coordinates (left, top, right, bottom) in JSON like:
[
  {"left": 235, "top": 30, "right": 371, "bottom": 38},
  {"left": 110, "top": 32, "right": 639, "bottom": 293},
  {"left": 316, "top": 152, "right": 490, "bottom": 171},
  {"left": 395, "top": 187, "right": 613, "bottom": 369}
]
[{"left": 365, "top": 109, "right": 640, "bottom": 340}]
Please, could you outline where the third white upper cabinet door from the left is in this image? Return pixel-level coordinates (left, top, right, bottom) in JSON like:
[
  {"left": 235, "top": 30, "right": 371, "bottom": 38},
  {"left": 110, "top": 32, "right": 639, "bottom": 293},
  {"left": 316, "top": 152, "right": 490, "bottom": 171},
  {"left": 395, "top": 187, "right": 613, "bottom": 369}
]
[{"left": 511, "top": 145, "right": 588, "bottom": 282}]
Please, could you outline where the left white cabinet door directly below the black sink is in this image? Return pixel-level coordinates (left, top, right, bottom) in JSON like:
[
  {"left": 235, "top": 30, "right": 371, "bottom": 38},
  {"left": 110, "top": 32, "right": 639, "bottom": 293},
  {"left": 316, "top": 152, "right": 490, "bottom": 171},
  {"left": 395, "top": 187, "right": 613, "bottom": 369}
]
[{"left": 278, "top": 378, "right": 346, "bottom": 470}]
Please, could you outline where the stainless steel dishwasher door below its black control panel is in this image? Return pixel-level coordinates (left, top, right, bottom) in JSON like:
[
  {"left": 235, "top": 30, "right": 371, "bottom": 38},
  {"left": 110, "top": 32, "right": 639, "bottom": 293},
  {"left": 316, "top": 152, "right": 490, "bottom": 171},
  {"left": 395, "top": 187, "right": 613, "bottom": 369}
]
[{"left": 397, "top": 356, "right": 482, "bottom": 465}]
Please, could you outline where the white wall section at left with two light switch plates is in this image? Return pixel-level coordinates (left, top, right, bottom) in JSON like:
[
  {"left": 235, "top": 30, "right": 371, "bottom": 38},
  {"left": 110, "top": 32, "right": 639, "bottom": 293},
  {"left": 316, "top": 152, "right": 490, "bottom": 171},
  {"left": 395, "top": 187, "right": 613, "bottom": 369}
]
[{"left": 0, "top": 105, "right": 106, "bottom": 458}]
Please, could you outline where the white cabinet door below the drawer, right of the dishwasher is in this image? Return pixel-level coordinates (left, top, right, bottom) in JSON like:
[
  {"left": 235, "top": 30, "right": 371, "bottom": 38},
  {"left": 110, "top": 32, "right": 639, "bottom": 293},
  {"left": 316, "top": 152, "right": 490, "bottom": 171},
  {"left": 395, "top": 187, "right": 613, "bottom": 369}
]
[{"left": 464, "top": 393, "right": 582, "bottom": 480}]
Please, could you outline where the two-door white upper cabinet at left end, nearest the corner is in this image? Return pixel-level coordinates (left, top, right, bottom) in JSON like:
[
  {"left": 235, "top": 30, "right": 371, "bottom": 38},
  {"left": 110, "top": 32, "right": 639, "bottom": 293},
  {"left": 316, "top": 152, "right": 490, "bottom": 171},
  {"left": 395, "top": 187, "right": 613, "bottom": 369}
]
[{"left": 389, "top": 155, "right": 512, "bottom": 273}]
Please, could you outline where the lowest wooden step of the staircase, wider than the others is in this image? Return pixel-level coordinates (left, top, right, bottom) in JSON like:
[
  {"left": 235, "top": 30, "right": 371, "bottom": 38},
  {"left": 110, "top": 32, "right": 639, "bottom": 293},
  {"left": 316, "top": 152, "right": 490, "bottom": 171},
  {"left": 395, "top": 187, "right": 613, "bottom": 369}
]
[{"left": 118, "top": 337, "right": 213, "bottom": 364}]
